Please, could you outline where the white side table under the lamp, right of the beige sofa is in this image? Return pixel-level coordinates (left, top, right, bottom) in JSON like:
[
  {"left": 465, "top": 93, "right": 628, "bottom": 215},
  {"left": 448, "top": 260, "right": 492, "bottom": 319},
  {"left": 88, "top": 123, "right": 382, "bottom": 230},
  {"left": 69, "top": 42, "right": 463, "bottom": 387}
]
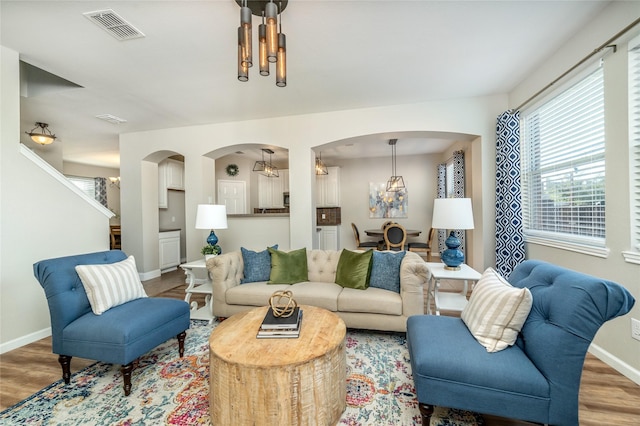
[{"left": 427, "top": 262, "right": 482, "bottom": 315}]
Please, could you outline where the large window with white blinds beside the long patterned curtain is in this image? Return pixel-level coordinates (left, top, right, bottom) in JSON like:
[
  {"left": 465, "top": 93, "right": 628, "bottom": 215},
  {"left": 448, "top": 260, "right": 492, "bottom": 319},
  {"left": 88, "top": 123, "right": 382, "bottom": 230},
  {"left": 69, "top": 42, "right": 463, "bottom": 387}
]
[{"left": 521, "top": 67, "right": 605, "bottom": 247}]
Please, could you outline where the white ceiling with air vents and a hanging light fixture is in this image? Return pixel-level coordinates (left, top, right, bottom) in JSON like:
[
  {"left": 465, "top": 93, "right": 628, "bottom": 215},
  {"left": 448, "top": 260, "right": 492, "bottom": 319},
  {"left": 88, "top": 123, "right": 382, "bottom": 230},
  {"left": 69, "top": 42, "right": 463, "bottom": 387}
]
[{"left": 0, "top": 0, "right": 609, "bottom": 167}]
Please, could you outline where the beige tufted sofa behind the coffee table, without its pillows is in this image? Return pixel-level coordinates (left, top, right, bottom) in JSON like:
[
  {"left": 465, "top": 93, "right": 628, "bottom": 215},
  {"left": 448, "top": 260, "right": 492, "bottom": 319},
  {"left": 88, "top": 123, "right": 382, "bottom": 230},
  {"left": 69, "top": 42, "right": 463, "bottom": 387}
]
[{"left": 207, "top": 250, "right": 428, "bottom": 331}]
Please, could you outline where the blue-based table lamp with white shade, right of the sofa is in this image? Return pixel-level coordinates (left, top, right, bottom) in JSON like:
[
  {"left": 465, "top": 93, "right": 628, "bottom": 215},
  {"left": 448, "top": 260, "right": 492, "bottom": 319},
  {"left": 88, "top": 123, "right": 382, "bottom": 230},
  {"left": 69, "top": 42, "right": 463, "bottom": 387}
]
[{"left": 431, "top": 198, "right": 473, "bottom": 270}]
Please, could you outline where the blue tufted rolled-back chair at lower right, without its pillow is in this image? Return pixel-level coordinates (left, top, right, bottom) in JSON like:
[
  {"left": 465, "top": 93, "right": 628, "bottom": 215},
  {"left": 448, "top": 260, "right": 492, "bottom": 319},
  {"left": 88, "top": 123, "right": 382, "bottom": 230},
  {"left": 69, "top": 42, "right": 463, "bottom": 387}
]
[{"left": 407, "top": 260, "right": 635, "bottom": 425}]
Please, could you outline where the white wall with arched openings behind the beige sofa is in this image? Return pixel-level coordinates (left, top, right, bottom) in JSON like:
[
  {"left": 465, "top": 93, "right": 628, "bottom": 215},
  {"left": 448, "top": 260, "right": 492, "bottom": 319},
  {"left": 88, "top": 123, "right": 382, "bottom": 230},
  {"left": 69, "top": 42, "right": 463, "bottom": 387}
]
[{"left": 120, "top": 96, "right": 506, "bottom": 273}]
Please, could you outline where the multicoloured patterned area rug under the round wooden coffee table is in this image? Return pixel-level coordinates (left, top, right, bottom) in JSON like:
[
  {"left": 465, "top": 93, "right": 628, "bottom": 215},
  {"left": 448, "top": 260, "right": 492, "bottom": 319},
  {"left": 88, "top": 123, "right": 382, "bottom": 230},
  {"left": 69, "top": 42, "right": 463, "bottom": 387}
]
[{"left": 0, "top": 321, "right": 483, "bottom": 426}]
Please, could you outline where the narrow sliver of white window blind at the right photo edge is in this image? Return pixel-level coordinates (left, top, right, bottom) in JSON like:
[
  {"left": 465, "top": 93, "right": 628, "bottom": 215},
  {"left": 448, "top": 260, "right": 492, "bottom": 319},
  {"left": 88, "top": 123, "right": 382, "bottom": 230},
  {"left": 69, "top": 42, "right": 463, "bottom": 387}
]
[{"left": 629, "top": 37, "right": 640, "bottom": 251}]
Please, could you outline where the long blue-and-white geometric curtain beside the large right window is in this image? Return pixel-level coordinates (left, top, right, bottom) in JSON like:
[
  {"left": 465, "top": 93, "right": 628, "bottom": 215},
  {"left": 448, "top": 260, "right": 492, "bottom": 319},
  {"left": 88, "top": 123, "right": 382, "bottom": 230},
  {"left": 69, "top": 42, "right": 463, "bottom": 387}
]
[{"left": 496, "top": 110, "right": 525, "bottom": 277}]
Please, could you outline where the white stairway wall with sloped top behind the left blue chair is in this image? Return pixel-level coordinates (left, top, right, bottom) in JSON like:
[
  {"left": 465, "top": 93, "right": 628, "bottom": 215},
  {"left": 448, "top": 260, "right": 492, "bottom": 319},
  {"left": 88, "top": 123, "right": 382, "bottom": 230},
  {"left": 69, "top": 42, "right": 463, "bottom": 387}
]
[{"left": 0, "top": 47, "right": 109, "bottom": 352}]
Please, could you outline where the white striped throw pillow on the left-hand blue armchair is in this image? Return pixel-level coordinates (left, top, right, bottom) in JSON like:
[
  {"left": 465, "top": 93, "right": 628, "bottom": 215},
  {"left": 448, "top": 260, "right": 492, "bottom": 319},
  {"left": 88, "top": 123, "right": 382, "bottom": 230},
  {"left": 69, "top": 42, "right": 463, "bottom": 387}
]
[{"left": 76, "top": 256, "right": 147, "bottom": 315}]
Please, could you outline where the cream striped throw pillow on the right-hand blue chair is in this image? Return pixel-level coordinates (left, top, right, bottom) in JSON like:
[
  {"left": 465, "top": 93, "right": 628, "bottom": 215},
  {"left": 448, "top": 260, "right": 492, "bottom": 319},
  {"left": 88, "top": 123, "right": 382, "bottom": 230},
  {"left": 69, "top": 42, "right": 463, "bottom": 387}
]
[{"left": 461, "top": 268, "right": 533, "bottom": 352}]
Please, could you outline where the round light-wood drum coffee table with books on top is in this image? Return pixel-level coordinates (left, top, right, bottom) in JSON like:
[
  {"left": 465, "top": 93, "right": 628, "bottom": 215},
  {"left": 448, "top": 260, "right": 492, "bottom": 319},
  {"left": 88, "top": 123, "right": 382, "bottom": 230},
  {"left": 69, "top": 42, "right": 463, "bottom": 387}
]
[{"left": 209, "top": 305, "right": 347, "bottom": 426}]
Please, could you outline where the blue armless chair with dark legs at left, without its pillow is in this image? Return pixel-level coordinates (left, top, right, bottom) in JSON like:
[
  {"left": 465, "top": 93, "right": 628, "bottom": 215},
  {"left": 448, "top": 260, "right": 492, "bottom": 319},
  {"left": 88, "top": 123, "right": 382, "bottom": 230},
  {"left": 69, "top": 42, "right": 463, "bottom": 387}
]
[{"left": 33, "top": 250, "right": 189, "bottom": 395}]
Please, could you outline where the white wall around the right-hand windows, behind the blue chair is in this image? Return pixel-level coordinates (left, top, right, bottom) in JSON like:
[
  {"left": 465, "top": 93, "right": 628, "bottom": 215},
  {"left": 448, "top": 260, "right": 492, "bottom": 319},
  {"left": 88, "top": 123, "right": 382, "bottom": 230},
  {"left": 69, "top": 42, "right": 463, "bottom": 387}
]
[{"left": 509, "top": 2, "right": 640, "bottom": 384}]
